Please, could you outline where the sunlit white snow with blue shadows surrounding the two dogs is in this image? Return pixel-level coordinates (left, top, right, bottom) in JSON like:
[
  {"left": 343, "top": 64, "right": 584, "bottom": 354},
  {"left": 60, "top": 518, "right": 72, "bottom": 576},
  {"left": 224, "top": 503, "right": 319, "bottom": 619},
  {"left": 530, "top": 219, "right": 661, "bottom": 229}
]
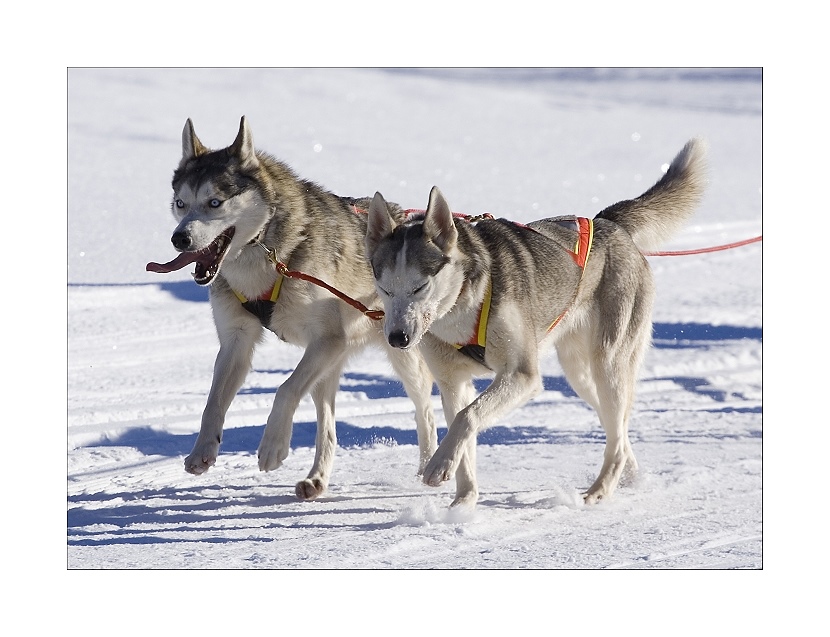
[{"left": 67, "top": 69, "right": 763, "bottom": 570}]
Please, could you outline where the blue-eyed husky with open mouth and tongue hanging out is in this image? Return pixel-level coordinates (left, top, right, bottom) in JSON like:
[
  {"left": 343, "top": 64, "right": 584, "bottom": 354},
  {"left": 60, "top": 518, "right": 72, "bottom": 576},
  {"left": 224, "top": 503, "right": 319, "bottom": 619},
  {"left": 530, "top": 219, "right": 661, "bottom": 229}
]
[{"left": 147, "top": 117, "right": 438, "bottom": 500}]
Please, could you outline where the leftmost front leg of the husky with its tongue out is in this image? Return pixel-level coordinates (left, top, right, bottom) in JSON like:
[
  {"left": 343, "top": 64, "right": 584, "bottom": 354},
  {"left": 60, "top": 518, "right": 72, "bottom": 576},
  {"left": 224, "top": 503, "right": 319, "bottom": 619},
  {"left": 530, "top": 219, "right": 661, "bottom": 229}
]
[{"left": 184, "top": 307, "right": 262, "bottom": 475}]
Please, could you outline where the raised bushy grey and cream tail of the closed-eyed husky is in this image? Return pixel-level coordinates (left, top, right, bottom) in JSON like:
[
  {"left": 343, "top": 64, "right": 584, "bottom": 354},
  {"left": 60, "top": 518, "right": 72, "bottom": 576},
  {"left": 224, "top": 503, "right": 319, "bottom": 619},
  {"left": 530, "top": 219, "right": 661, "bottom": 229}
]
[{"left": 596, "top": 139, "right": 706, "bottom": 252}]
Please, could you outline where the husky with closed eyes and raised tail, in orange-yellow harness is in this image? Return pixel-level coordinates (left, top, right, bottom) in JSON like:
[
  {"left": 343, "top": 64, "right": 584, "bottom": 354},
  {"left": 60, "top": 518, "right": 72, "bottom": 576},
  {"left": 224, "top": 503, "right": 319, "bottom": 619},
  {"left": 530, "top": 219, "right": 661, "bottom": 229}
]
[{"left": 366, "top": 140, "right": 705, "bottom": 505}]
